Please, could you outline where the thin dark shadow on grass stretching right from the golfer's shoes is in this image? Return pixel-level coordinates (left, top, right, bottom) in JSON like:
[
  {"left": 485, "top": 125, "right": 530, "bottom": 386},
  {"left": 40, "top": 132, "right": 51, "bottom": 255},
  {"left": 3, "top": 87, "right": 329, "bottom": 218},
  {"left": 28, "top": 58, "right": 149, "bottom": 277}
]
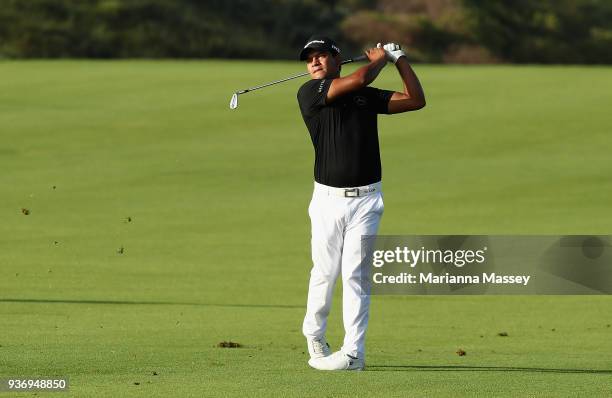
[{"left": 366, "top": 365, "right": 612, "bottom": 375}]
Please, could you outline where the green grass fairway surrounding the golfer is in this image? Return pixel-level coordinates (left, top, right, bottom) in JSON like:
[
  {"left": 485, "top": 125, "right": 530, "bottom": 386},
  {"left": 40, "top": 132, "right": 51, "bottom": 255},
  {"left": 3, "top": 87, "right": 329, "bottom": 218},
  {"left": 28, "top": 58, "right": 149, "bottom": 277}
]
[{"left": 0, "top": 61, "right": 612, "bottom": 398}]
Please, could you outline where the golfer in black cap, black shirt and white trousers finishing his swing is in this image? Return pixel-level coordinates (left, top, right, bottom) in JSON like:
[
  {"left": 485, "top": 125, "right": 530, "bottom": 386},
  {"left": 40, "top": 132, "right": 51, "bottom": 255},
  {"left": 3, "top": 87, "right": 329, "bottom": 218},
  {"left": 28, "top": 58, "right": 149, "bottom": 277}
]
[{"left": 297, "top": 36, "right": 425, "bottom": 370}]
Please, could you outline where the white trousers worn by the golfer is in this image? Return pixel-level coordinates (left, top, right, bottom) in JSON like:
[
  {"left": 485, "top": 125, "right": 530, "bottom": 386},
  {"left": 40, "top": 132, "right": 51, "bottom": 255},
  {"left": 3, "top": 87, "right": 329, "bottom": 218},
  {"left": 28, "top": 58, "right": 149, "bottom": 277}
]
[{"left": 302, "top": 182, "right": 384, "bottom": 358}]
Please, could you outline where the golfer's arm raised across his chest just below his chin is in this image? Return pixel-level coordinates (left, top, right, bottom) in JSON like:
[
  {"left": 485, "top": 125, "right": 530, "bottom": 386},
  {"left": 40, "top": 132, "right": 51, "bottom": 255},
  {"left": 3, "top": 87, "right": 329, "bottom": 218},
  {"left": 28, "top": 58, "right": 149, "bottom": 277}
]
[{"left": 325, "top": 48, "right": 388, "bottom": 104}]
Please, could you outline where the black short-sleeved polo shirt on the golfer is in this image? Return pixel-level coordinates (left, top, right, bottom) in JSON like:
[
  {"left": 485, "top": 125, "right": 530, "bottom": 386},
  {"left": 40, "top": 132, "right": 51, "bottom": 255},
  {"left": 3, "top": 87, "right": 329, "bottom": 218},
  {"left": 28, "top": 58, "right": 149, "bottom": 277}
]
[{"left": 297, "top": 79, "right": 393, "bottom": 188}]
